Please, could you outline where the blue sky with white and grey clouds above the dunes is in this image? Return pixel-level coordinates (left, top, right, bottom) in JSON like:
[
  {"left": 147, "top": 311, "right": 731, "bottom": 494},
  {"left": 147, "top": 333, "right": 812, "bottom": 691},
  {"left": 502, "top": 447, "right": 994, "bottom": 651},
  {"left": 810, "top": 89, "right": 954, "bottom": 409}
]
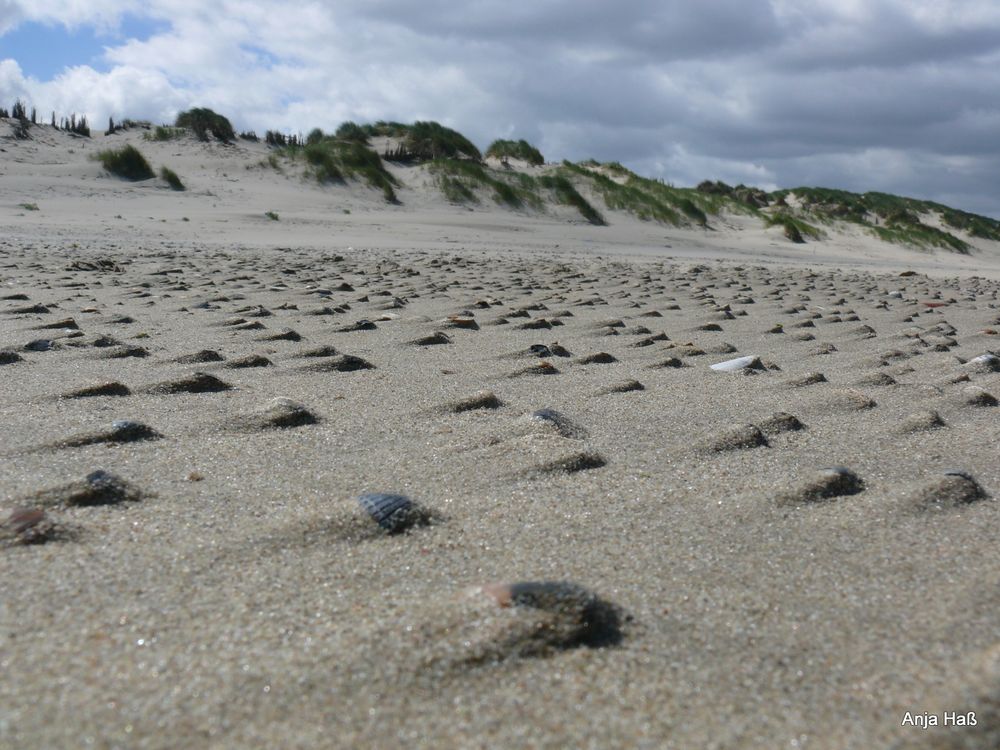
[{"left": 0, "top": 0, "right": 1000, "bottom": 217}]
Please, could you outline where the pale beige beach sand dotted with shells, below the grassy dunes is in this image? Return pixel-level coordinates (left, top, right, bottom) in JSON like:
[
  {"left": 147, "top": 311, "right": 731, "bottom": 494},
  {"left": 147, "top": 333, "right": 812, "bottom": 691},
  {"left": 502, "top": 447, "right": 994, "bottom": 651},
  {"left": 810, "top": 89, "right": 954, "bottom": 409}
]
[{"left": 0, "top": 125, "right": 1000, "bottom": 748}]
